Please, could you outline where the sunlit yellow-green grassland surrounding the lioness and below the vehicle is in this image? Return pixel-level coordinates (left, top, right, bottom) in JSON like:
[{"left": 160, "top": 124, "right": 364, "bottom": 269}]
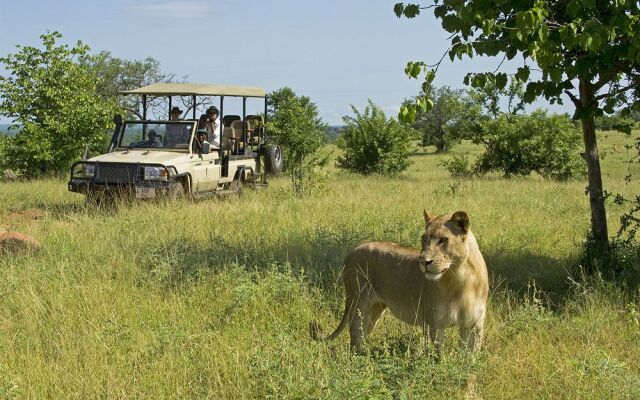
[{"left": 0, "top": 132, "right": 640, "bottom": 399}]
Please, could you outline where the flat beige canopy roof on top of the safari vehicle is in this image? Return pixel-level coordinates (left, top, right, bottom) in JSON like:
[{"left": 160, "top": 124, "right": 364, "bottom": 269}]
[{"left": 118, "top": 83, "right": 266, "bottom": 97}]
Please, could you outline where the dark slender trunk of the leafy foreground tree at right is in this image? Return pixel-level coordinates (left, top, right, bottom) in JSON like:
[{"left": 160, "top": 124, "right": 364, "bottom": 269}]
[{"left": 580, "top": 79, "right": 609, "bottom": 249}]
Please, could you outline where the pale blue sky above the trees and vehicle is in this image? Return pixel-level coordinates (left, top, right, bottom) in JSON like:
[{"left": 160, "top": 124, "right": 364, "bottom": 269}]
[{"left": 0, "top": 0, "right": 563, "bottom": 125}]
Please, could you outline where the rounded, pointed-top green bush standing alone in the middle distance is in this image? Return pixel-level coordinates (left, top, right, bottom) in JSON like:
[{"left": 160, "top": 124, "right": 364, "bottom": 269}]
[{"left": 338, "top": 100, "right": 413, "bottom": 175}]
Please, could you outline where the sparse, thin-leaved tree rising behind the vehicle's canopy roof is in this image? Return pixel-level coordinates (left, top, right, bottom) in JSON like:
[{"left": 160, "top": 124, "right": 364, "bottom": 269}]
[{"left": 80, "top": 51, "right": 180, "bottom": 119}]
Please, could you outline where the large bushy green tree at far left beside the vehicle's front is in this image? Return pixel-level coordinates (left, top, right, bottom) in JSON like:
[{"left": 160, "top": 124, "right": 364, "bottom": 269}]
[{"left": 0, "top": 32, "right": 116, "bottom": 176}]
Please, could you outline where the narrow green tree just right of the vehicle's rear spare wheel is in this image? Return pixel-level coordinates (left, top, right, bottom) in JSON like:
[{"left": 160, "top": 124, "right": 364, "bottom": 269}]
[{"left": 267, "top": 87, "right": 328, "bottom": 195}]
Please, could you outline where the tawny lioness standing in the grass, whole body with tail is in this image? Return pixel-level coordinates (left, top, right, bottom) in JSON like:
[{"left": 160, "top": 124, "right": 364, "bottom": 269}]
[{"left": 309, "top": 211, "right": 489, "bottom": 353}]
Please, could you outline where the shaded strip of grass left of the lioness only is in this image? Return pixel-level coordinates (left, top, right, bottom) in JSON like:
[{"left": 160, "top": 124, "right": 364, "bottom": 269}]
[{"left": 137, "top": 228, "right": 366, "bottom": 291}]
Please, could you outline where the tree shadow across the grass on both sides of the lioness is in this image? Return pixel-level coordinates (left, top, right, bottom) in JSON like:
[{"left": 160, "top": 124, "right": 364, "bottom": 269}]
[{"left": 141, "top": 228, "right": 578, "bottom": 301}]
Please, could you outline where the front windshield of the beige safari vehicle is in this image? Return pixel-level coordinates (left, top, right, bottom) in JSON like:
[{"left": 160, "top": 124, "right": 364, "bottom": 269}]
[{"left": 118, "top": 121, "right": 195, "bottom": 149}]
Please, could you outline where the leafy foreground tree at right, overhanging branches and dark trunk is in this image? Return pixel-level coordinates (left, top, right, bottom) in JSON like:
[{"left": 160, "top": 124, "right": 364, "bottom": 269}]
[{"left": 394, "top": 0, "right": 640, "bottom": 249}]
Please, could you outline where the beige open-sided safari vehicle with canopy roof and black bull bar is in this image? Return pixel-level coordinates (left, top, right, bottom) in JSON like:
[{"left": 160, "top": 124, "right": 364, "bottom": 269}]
[{"left": 68, "top": 83, "right": 283, "bottom": 202}]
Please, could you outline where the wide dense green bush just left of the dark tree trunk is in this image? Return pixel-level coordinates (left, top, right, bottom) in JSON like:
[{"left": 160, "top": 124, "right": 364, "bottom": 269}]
[{"left": 475, "top": 110, "right": 585, "bottom": 180}]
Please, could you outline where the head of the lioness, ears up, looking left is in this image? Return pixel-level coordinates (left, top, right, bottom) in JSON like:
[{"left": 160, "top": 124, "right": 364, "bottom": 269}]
[{"left": 419, "top": 211, "right": 469, "bottom": 280}]
